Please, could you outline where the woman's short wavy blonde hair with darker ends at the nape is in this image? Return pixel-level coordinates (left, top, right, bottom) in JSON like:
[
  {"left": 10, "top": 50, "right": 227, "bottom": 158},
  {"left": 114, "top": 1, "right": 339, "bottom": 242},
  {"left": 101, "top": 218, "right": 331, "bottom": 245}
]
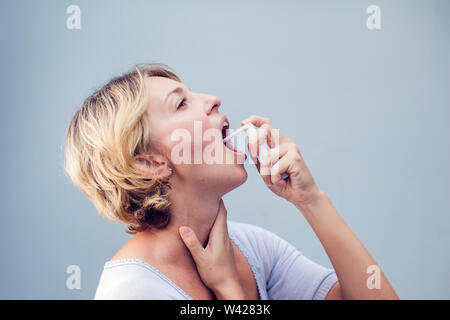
[{"left": 64, "top": 63, "right": 181, "bottom": 234}]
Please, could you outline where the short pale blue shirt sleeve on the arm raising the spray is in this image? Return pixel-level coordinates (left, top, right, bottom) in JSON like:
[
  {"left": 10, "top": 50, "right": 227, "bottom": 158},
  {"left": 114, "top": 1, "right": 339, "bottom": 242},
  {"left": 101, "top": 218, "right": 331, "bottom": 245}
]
[{"left": 250, "top": 222, "right": 337, "bottom": 300}]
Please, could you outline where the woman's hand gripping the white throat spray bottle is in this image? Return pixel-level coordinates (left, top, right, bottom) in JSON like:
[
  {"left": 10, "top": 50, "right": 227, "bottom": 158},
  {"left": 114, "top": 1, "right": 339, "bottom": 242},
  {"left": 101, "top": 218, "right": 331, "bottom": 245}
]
[{"left": 241, "top": 115, "right": 321, "bottom": 205}]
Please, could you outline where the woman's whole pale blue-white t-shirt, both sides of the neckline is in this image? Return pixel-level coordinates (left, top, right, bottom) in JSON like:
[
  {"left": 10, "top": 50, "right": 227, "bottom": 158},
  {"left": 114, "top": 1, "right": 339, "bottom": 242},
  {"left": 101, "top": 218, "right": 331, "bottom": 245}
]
[{"left": 94, "top": 221, "right": 337, "bottom": 300}]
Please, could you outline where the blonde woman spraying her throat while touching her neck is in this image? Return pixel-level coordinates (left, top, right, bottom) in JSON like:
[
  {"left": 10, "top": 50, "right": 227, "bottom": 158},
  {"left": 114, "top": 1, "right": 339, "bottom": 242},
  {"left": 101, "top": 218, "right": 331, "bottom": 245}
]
[{"left": 65, "top": 64, "right": 398, "bottom": 299}]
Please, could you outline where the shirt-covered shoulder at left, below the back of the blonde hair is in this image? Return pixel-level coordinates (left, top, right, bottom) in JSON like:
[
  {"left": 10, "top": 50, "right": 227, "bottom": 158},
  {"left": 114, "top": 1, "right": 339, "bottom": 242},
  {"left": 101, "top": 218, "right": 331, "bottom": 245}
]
[{"left": 94, "top": 259, "right": 187, "bottom": 300}]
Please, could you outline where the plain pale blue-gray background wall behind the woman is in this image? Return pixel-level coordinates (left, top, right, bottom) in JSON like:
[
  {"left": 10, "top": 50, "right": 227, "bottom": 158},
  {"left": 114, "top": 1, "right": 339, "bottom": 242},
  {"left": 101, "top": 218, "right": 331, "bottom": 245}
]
[{"left": 0, "top": 0, "right": 450, "bottom": 299}]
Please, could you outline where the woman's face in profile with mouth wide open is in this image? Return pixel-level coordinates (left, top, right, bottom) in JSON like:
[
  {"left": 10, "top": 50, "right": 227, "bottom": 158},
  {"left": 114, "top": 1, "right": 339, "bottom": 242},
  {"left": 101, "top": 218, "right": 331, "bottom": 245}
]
[{"left": 146, "top": 77, "right": 247, "bottom": 194}]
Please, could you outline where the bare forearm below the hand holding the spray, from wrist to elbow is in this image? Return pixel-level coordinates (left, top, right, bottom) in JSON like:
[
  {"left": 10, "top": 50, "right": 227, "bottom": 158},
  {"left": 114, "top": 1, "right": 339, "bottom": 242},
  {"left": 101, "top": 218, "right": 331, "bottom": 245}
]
[{"left": 293, "top": 187, "right": 399, "bottom": 299}]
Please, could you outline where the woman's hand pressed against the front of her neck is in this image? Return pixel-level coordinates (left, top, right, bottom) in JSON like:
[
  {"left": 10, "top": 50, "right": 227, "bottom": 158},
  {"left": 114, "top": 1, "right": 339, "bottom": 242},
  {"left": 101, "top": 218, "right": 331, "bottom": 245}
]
[{"left": 179, "top": 199, "right": 247, "bottom": 300}]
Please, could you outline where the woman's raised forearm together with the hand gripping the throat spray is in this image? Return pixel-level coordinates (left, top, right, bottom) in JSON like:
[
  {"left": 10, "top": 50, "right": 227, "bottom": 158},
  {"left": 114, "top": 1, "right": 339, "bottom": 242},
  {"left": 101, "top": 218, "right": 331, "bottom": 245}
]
[{"left": 241, "top": 115, "right": 398, "bottom": 299}]
